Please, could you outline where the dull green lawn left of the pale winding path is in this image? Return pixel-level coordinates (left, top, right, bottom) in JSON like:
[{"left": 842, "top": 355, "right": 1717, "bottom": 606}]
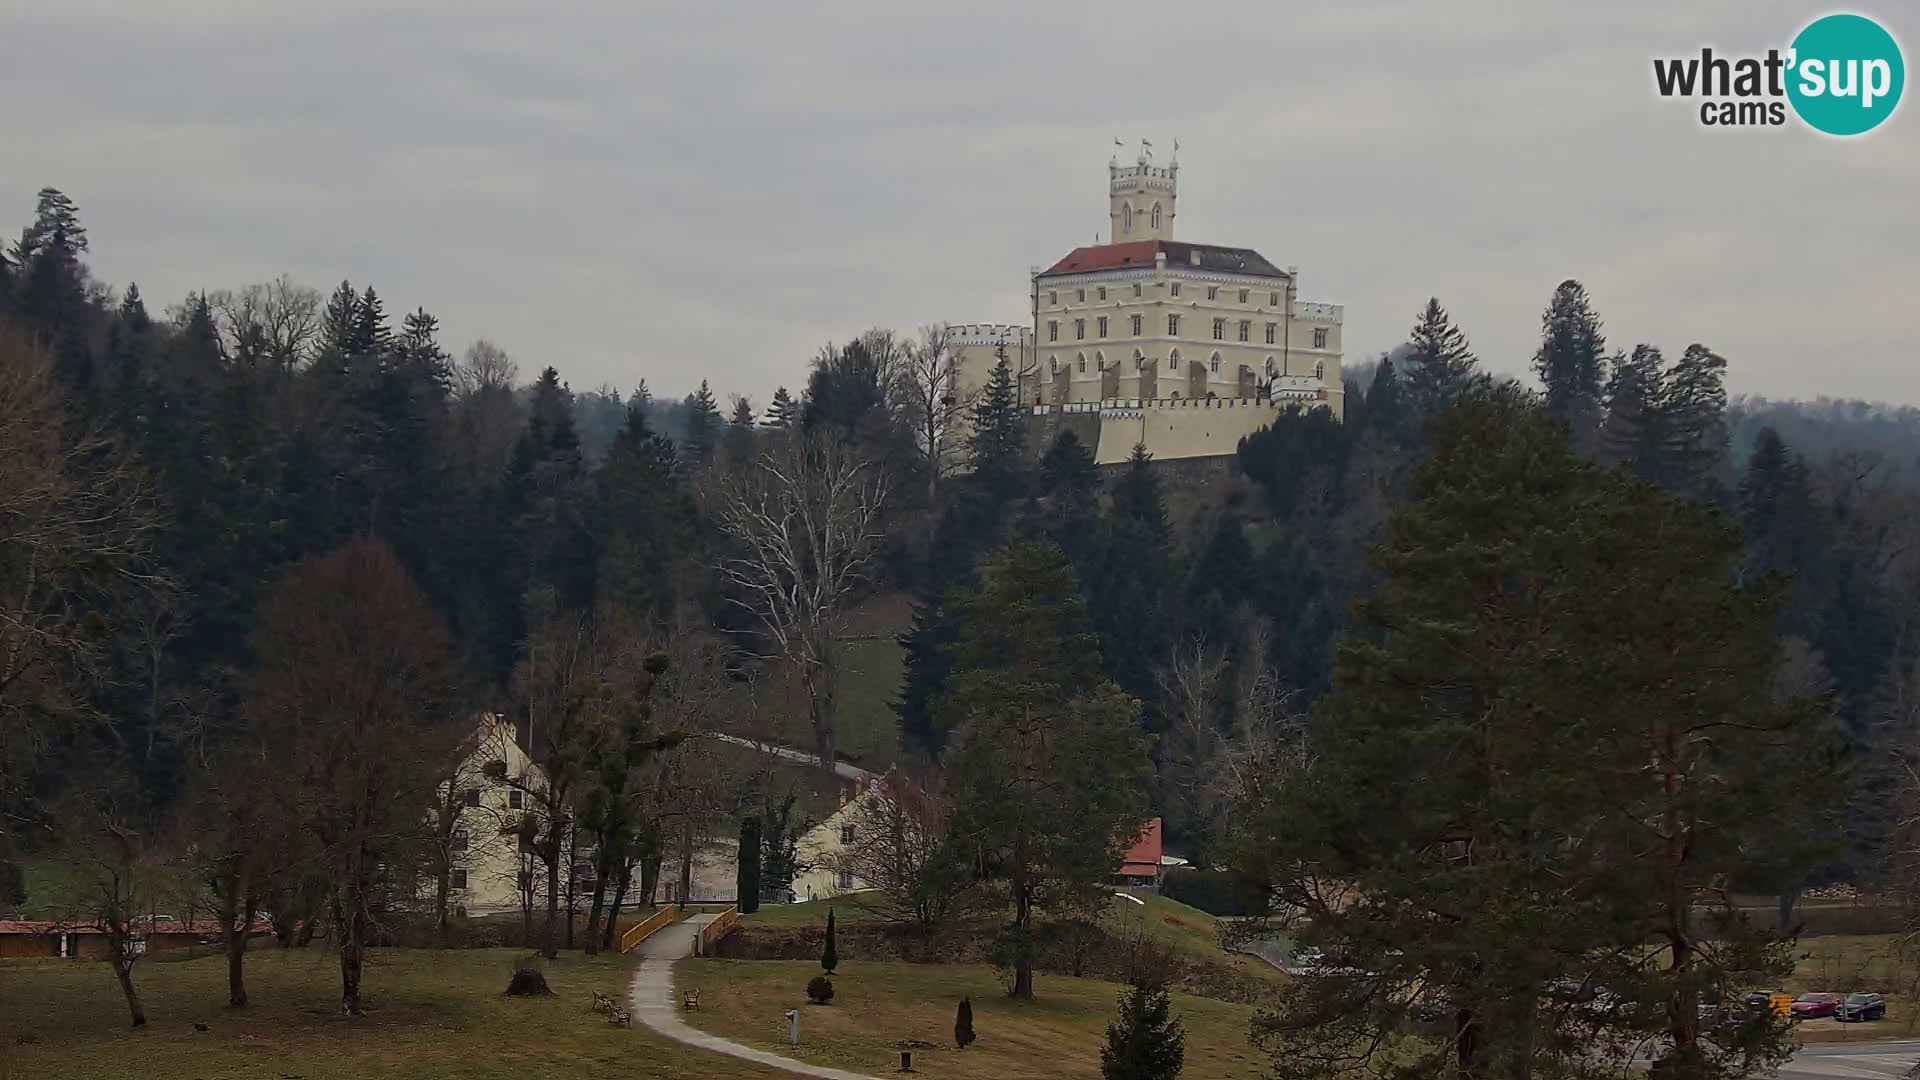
[{"left": 0, "top": 949, "right": 785, "bottom": 1080}]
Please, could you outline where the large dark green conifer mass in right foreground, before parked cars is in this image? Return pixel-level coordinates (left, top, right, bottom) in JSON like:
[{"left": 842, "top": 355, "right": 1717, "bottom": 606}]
[{"left": 1246, "top": 394, "right": 1834, "bottom": 1078}]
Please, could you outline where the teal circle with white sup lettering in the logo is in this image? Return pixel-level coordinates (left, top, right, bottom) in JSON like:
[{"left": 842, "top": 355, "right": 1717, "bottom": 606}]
[{"left": 1788, "top": 15, "right": 1907, "bottom": 135}]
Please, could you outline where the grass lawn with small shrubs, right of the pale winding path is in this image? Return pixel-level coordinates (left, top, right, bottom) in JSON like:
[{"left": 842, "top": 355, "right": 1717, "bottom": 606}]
[{"left": 674, "top": 959, "right": 1267, "bottom": 1080}]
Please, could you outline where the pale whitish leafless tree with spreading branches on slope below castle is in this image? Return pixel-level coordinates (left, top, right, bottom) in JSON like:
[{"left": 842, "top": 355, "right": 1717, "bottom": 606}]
[{"left": 718, "top": 438, "right": 887, "bottom": 771}]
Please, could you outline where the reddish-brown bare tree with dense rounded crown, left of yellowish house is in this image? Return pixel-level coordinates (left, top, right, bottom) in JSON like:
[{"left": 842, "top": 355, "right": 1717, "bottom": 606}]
[{"left": 246, "top": 540, "right": 465, "bottom": 1015}]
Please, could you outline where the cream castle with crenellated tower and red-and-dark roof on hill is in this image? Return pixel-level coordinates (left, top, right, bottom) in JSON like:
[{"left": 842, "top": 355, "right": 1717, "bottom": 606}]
[{"left": 950, "top": 142, "right": 1344, "bottom": 465}]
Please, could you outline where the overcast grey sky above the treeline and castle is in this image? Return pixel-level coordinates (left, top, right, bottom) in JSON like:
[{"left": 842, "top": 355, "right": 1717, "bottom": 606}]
[{"left": 0, "top": 0, "right": 1920, "bottom": 405}]
